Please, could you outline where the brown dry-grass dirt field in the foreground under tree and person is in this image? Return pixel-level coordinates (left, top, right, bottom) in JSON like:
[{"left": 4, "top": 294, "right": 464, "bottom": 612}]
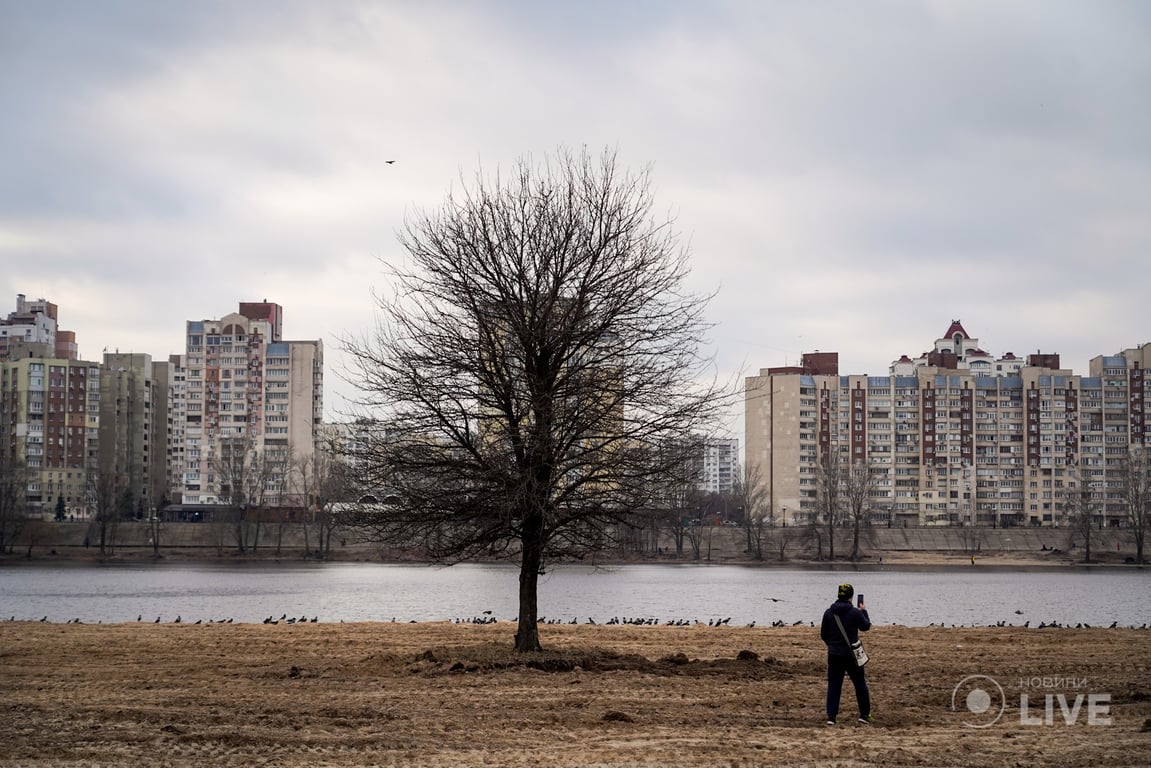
[{"left": 0, "top": 622, "right": 1151, "bottom": 767}]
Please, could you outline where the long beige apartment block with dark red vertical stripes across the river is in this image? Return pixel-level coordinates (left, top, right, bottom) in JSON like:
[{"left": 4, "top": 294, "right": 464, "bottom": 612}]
[{"left": 745, "top": 321, "right": 1151, "bottom": 526}]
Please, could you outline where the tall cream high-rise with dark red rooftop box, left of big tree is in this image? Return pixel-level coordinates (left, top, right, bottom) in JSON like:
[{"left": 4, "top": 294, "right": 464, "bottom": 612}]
[{"left": 179, "top": 302, "right": 323, "bottom": 505}]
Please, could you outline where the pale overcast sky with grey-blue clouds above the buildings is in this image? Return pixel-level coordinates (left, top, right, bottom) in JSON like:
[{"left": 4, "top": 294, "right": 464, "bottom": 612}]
[{"left": 0, "top": 0, "right": 1151, "bottom": 435}]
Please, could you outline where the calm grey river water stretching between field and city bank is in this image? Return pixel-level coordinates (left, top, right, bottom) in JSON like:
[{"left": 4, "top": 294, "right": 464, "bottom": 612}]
[{"left": 0, "top": 562, "right": 1151, "bottom": 626}]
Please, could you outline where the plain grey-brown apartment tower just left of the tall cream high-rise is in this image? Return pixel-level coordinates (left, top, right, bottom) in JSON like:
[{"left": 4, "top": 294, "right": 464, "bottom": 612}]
[{"left": 97, "top": 352, "right": 169, "bottom": 518}]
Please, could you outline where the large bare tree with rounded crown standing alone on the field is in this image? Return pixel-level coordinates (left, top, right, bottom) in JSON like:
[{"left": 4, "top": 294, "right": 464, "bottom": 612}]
[{"left": 345, "top": 150, "right": 721, "bottom": 652}]
